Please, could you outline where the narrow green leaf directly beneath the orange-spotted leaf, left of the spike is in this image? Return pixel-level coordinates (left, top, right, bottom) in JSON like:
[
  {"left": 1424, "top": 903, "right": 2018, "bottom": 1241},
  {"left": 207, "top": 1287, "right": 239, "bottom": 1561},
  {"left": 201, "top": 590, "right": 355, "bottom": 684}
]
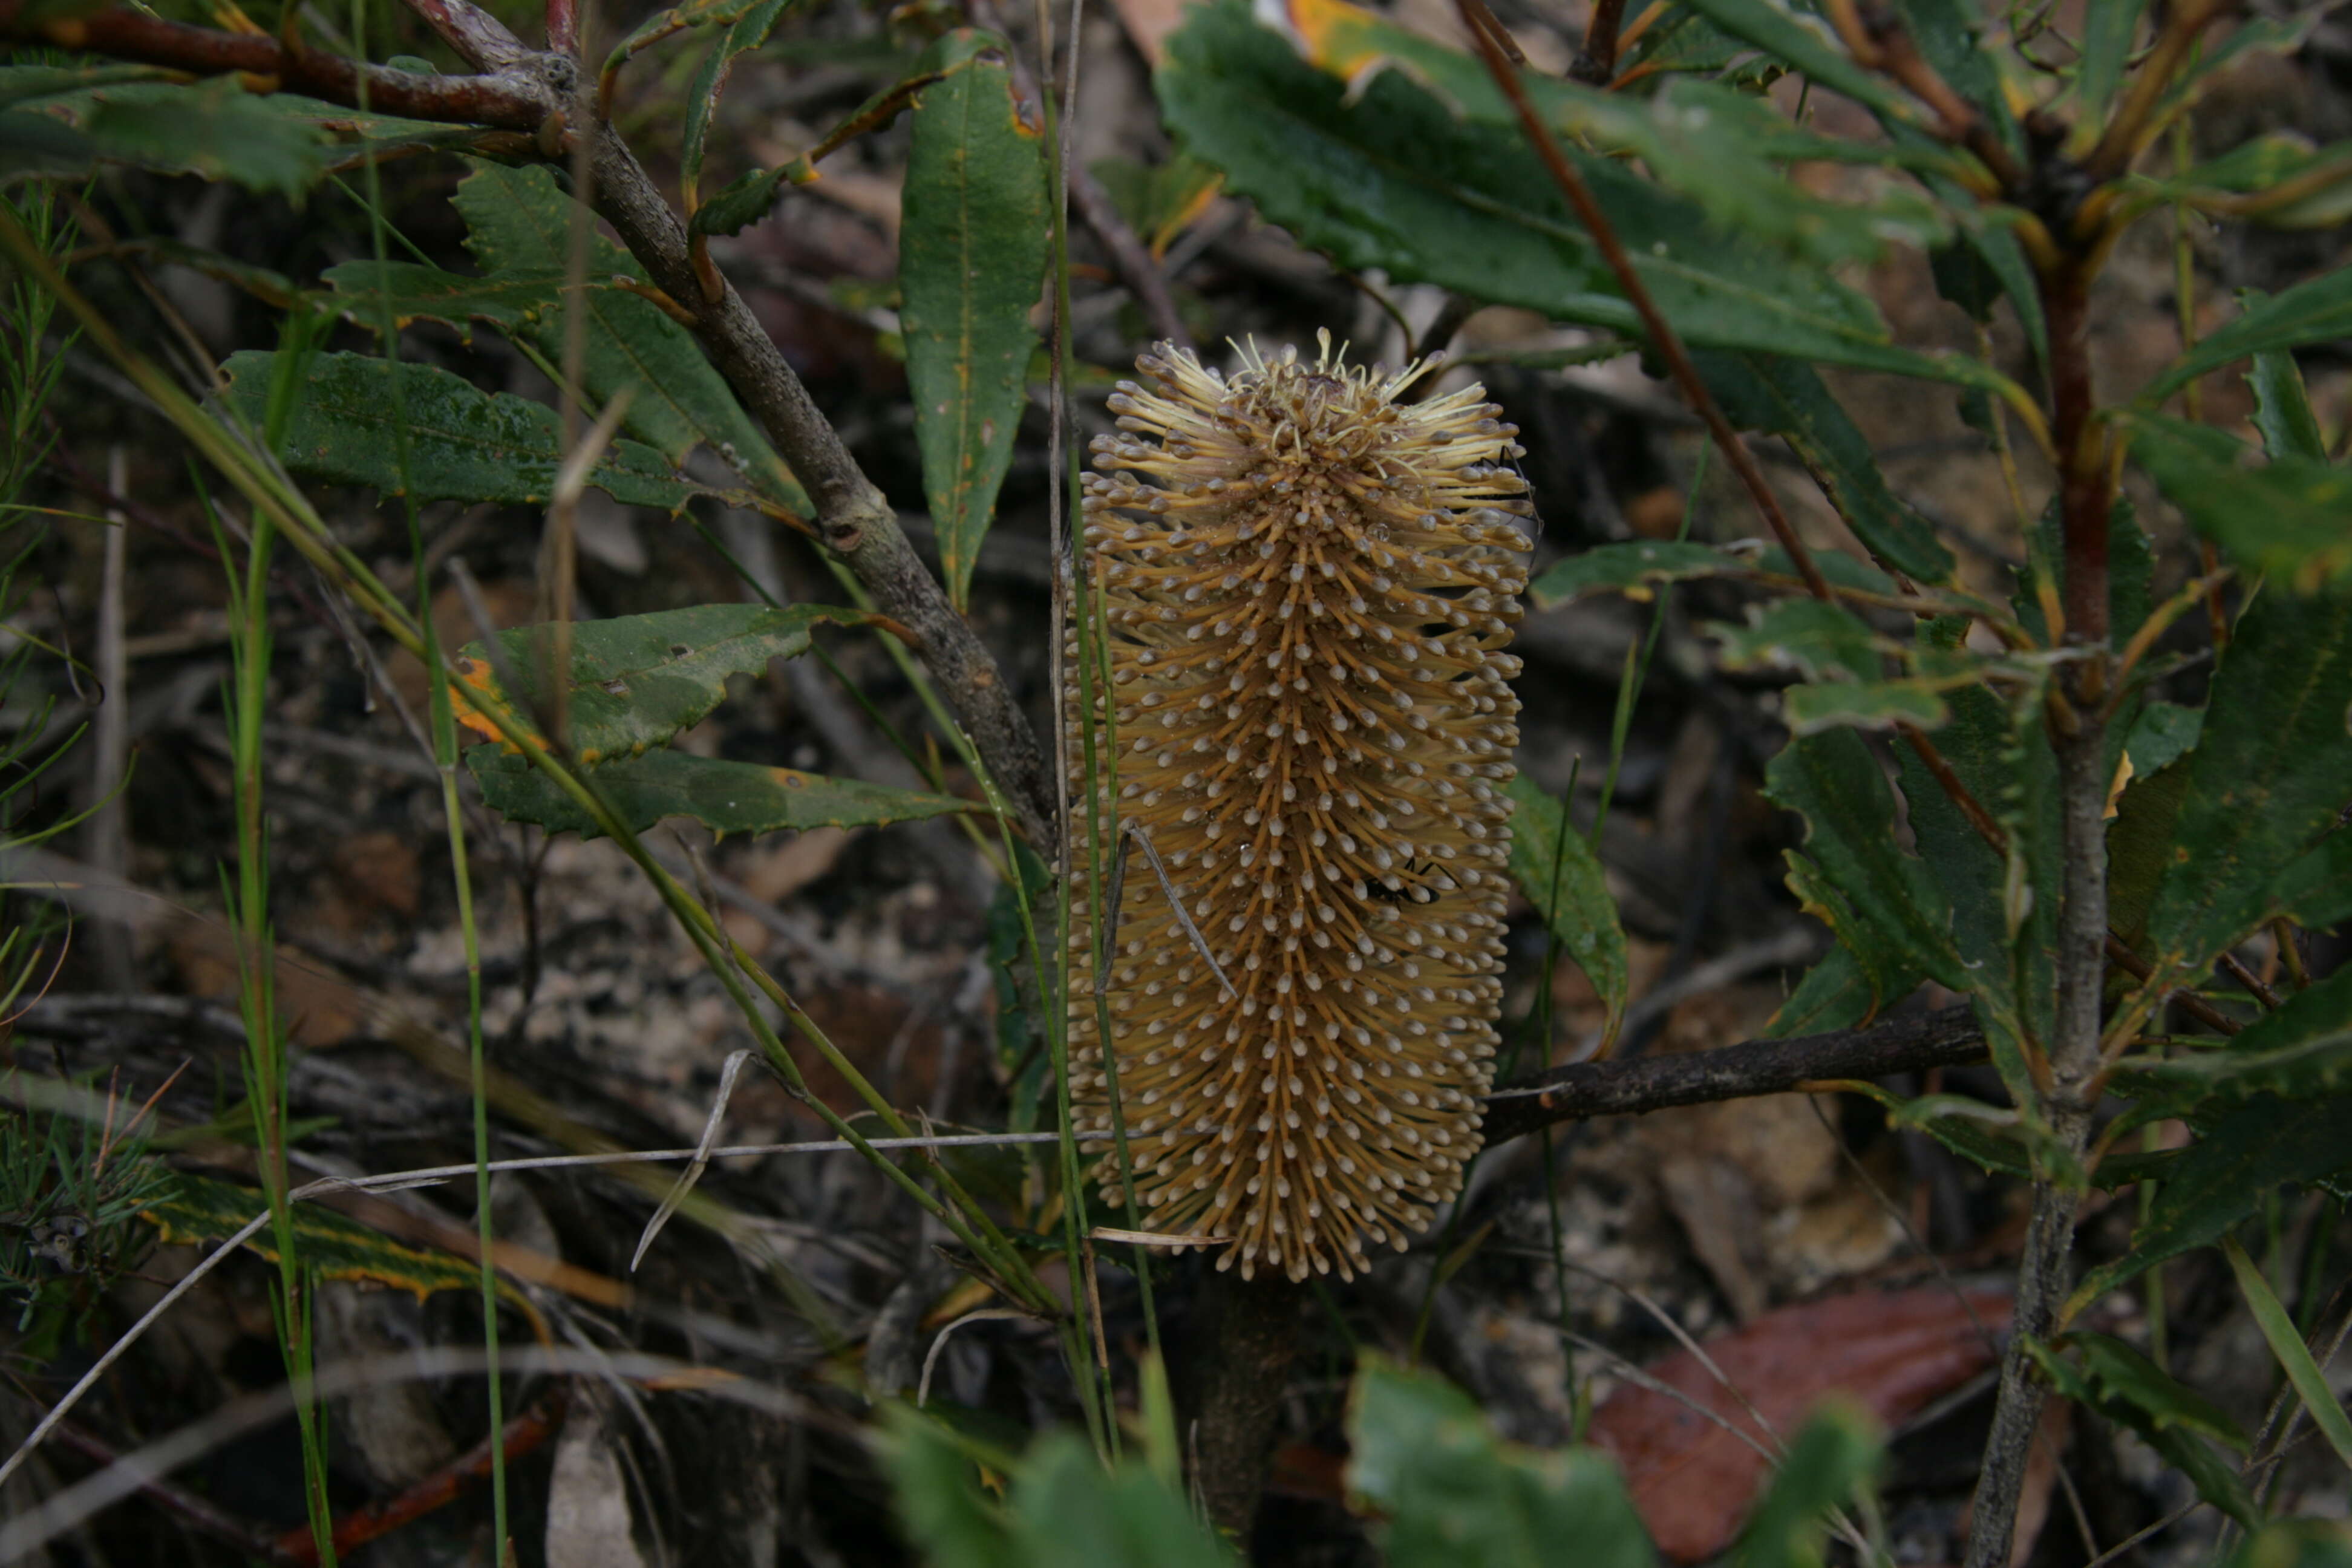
[{"left": 466, "top": 745, "right": 978, "bottom": 839}]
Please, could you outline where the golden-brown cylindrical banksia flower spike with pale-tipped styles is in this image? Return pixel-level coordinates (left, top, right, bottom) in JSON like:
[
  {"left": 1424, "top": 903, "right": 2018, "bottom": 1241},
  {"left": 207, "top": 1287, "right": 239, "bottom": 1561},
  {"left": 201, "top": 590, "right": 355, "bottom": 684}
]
[{"left": 1065, "top": 336, "right": 1526, "bottom": 1279}]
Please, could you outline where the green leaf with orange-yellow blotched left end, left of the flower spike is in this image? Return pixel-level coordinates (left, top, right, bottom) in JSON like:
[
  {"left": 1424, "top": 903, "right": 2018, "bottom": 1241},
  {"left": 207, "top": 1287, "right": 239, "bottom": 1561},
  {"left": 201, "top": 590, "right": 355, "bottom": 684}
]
[{"left": 456, "top": 604, "right": 868, "bottom": 766}]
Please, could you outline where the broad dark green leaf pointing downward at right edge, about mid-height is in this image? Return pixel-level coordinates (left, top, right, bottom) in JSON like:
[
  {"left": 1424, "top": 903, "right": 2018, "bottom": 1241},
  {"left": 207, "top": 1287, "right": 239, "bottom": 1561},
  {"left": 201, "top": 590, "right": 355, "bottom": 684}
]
[{"left": 2148, "top": 586, "right": 2352, "bottom": 976}]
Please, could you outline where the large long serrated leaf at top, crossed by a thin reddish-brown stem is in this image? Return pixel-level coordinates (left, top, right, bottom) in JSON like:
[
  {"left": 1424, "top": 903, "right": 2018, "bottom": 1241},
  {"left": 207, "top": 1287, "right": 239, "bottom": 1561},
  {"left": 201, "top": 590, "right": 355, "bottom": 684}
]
[{"left": 1157, "top": 2, "right": 2013, "bottom": 397}]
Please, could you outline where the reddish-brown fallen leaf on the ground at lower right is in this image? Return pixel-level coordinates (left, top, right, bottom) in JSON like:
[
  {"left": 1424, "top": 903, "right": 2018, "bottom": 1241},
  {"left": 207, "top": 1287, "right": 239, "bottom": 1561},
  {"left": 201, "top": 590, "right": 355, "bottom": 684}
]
[{"left": 1592, "top": 1286, "right": 2008, "bottom": 1563}]
